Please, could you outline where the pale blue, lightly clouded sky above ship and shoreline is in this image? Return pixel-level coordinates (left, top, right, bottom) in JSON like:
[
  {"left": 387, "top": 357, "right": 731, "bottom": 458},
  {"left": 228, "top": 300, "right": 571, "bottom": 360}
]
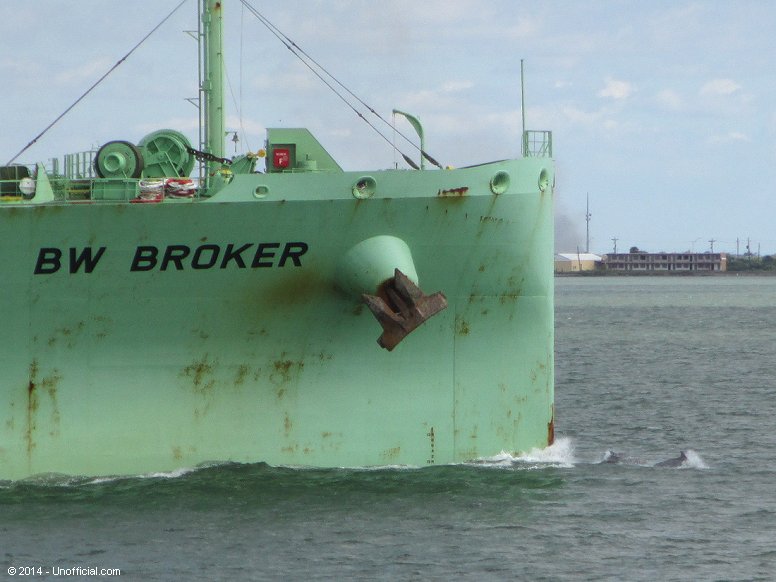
[{"left": 0, "top": 0, "right": 776, "bottom": 255}]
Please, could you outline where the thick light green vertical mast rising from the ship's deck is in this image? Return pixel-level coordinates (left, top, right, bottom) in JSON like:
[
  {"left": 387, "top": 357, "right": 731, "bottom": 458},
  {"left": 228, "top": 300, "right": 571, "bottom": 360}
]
[{"left": 202, "top": 0, "right": 226, "bottom": 181}]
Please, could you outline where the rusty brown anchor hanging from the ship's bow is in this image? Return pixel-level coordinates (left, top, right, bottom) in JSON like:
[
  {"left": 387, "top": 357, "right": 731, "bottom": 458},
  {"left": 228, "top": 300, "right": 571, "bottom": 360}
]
[{"left": 362, "top": 269, "right": 447, "bottom": 351}]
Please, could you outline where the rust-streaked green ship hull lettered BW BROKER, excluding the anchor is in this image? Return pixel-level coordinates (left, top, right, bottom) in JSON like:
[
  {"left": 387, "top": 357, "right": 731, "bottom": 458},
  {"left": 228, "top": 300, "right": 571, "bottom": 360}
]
[{"left": 0, "top": 3, "right": 554, "bottom": 479}]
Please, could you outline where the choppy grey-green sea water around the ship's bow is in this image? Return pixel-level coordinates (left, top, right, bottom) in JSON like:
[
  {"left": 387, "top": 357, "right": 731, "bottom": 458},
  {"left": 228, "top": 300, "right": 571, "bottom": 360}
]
[{"left": 0, "top": 276, "right": 776, "bottom": 580}]
